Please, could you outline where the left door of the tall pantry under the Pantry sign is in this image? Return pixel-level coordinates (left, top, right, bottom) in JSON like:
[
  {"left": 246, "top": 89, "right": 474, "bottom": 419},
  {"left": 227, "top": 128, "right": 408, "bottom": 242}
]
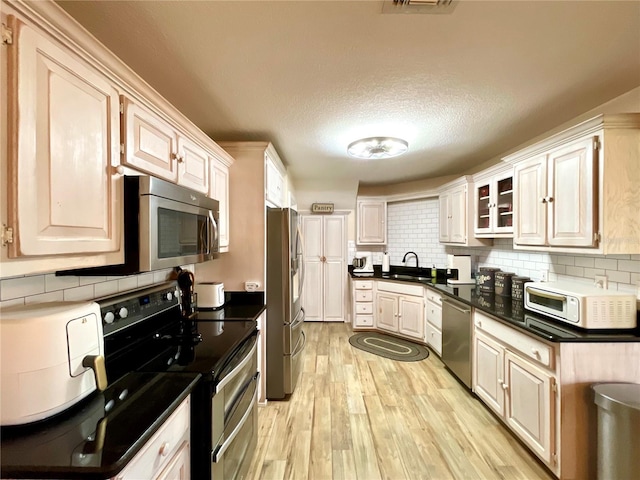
[{"left": 302, "top": 215, "right": 324, "bottom": 322}]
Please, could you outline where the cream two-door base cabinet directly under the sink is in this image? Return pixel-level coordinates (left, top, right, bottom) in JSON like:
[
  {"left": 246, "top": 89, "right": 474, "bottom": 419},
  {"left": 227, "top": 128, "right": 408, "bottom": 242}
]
[{"left": 375, "top": 281, "right": 426, "bottom": 343}]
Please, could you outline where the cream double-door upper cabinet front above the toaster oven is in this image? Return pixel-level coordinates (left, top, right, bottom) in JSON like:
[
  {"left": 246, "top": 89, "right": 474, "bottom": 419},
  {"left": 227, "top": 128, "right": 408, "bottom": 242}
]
[{"left": 514, "top": 136, "right": 598, "bottom": 247}]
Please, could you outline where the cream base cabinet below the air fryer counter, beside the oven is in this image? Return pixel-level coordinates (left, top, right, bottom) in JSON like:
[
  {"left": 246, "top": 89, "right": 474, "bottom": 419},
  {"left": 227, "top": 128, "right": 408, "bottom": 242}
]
[{"left": 114, "top": 397, "right": 191, "bottom": 480}]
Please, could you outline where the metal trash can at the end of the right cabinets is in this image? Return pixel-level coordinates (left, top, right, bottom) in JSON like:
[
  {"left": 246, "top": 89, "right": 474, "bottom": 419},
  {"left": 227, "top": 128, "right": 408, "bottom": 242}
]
[{"left": 591, "top": 383, "right": 640, "bottom": 480}]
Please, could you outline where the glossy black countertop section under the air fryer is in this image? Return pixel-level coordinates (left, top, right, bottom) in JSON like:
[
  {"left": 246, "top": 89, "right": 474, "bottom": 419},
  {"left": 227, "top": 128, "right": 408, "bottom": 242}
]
[{"left": 0, "top": 372, "right": 200, "bottom": 479}]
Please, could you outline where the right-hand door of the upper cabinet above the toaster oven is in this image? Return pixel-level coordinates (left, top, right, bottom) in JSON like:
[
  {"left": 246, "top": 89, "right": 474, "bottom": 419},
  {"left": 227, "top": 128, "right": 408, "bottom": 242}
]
[{"left": 546, "top": 137, "right": 598, "bottom": 247}]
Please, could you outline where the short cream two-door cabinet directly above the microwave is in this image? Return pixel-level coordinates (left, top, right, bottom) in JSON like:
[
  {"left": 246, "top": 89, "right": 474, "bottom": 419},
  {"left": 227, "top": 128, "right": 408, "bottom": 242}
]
[{"left": 120, "top": 95, "right": 209, "bottom": 193}]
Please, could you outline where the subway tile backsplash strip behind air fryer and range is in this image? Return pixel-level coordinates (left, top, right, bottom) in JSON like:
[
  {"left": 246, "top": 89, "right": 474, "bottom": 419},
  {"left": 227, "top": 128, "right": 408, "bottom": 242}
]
[{"left": 0, "top": 265, "right": 195, "bottom": 307}]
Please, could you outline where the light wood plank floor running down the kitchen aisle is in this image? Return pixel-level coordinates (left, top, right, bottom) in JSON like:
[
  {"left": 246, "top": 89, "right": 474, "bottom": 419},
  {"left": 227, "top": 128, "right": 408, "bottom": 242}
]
[{"left": 249, "top": 323, "right": 554, "bottom": 480}]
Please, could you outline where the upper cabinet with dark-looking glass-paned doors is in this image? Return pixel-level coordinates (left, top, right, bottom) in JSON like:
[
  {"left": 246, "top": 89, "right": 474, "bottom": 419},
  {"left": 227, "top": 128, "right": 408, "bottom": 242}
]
[{"left": 473, "top": 164, "right": 513, "bottom": 238}]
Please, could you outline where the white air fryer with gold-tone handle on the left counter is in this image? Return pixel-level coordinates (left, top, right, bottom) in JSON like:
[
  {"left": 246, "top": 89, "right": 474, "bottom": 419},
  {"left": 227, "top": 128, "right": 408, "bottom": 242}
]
[{"left": 0, "top": 301, "right": 107, "bottom": 426}]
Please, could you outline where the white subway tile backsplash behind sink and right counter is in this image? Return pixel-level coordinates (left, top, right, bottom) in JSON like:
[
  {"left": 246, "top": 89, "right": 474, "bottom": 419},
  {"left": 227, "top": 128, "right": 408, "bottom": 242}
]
[{"left": 360, "top": 198, "right": 640, "bottom": 294}]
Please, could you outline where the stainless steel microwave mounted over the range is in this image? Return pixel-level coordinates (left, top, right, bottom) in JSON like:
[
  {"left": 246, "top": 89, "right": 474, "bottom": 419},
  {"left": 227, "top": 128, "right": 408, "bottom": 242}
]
[{"left": 57, "top": 176, "right": 219, "bottom": 275}]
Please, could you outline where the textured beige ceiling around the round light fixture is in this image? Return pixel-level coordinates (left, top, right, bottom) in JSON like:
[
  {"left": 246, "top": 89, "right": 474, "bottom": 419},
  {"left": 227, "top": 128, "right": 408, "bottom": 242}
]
[{"left": 58, "top": 0, "right": 640, "bottom": 189}]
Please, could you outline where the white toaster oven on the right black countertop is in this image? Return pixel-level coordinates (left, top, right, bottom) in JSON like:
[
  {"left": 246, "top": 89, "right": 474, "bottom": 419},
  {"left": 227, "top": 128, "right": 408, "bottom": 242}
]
[{"left": 524, "top": 282, "right": 638, "bottom": 329}]
